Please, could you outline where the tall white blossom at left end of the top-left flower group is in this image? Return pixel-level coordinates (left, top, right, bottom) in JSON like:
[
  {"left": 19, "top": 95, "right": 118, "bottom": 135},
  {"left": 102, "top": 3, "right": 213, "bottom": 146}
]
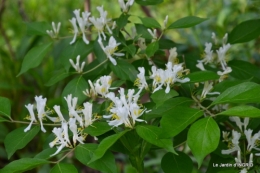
[{"left": 73, "top": 9, "right": 91, "bottom": 44}]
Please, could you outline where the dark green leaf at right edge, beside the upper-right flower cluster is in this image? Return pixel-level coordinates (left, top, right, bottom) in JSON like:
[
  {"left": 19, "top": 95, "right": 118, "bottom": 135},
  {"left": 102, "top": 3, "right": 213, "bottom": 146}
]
[{"left": 228, "top": 60, "right": 260, "bottom": 83}]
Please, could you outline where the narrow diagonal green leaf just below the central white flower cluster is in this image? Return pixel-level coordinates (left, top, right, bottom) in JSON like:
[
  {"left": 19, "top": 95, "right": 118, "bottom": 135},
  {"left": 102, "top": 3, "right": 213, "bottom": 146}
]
[{"left": 89, "top": 130, "right": 128, "bottom": 164}]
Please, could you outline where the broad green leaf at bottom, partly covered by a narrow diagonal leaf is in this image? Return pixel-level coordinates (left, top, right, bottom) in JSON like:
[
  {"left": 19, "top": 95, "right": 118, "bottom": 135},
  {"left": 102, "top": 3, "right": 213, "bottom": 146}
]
[{"left": 75, "top": 144, "right": 117, "bottom": 173}]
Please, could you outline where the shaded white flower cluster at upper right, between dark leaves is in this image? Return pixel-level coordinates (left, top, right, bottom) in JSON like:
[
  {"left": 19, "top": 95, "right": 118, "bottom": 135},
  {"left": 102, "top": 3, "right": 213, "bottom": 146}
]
[{"left": 196, "top": 33, "right": 232, "bottom": 81}]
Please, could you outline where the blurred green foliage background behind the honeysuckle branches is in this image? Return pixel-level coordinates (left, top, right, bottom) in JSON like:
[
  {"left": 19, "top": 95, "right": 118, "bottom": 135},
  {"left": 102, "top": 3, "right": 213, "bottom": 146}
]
[{"left": 0, "top": 0, "right": 260, "bottom": 173}]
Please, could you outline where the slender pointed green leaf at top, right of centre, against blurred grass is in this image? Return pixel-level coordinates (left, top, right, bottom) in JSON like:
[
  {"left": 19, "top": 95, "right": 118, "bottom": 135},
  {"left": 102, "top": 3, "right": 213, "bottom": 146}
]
[{"left": 167, "top": 16, "right": 207, "bottom": 29}]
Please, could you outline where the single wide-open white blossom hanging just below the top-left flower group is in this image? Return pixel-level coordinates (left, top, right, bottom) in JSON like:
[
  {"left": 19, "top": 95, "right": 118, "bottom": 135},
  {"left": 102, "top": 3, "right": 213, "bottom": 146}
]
[{"left": 98, "top": 36, "right": 125, "bottom": 65}]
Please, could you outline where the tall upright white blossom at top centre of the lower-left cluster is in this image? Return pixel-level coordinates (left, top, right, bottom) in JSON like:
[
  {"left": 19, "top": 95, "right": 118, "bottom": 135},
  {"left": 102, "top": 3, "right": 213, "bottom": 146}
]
[{"left": 64, "top": 94, "right": 83, "bottom": 127}]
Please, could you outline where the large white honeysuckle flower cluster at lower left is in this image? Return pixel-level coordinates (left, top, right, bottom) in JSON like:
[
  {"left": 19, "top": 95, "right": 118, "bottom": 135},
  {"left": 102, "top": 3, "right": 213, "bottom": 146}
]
[{"left": 24, "top": 94, "right": 97, "bottom": 156}]
